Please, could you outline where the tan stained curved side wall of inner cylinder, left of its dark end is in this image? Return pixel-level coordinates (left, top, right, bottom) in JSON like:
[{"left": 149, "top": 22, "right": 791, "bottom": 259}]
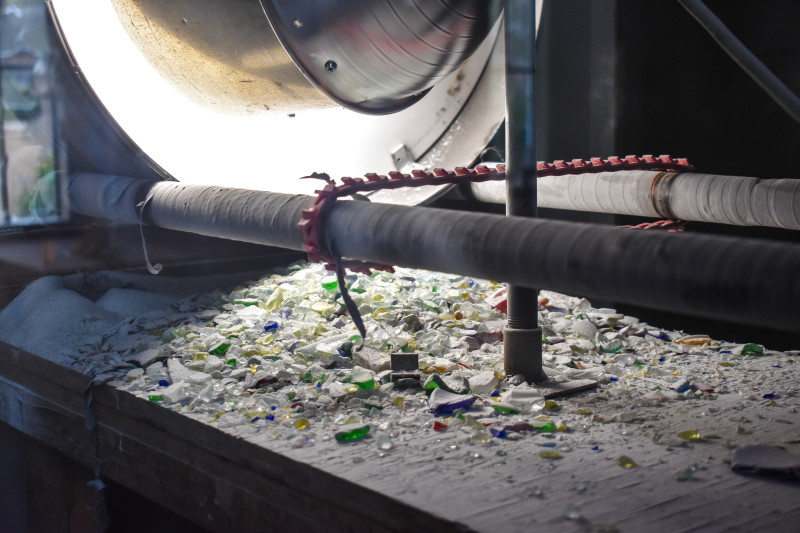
[{"left": 112, "top": 0, "right": 333, "bottom": 114}]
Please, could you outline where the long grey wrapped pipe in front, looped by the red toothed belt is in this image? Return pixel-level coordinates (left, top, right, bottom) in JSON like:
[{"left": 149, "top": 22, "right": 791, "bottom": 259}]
[{"left": 70, "top": 175, "right": 800, "bottom": 332}]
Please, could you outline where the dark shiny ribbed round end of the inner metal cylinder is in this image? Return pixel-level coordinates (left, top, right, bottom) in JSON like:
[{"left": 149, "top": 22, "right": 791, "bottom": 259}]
[{"left": 261, "top": 0, "right": 503, "bottom": 114}]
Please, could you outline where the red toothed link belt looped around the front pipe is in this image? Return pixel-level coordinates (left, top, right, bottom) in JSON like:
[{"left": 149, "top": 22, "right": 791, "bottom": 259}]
[{"left": 297, "top": 155, "right": 694, "bottom": 274}]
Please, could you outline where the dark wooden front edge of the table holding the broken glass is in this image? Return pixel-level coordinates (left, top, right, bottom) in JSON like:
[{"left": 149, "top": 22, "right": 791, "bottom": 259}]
[{"left": 0, "top": 342, "right": 470, "bottom": 532}]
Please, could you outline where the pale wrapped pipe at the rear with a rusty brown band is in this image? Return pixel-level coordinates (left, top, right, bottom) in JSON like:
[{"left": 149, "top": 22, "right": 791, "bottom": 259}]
[{"left": 470, "top": 170, "right": 800, "bottom": 230}]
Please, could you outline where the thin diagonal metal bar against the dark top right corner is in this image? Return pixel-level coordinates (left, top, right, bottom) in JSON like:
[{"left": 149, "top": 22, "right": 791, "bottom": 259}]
[{"left": 678, "top": 0, "right": 800, "bottom": 122}]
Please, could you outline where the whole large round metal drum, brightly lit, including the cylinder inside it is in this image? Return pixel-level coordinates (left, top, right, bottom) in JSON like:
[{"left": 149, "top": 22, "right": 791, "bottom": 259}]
[{"left": 50, "top": 0, "right": 541, "bottom": 204}]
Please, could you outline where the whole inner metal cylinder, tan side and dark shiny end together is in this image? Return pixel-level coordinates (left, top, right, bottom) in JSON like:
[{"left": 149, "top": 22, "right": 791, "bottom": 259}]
[{"left": 113, "top": 0, "right": 502, "bottom": 114}]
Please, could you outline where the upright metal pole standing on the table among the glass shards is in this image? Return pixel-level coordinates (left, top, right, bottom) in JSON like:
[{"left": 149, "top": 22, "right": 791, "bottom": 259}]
[{"left": 503, "top": 0, "right": 547, "bottom": 383}]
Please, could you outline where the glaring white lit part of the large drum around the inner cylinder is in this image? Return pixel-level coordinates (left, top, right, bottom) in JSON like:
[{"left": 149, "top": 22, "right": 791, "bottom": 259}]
[{"left": 50, "top": 0, "right": 512, "bottom": 203}]
